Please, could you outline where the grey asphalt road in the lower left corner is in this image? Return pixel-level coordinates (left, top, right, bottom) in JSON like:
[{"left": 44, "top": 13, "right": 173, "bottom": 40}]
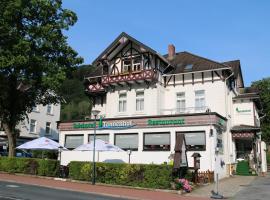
[{"left": 0, "top": 181, "right": 127, "bottom": 200}]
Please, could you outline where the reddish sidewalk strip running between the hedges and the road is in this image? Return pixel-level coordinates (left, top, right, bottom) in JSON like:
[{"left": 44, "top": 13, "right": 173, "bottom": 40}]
[{"left": 0, "top": 173, "right": 209, "bottom": 200}]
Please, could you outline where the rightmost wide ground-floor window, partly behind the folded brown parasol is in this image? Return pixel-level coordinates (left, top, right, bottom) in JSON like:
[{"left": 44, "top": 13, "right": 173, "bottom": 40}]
[{"left": 184, "top": 132, "right": 206, "bottom": 151}]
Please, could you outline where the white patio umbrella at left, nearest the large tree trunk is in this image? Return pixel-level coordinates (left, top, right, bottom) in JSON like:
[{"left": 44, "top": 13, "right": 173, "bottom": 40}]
[{"left": 16, "top": 137, "right": 67, "bottom": 150}]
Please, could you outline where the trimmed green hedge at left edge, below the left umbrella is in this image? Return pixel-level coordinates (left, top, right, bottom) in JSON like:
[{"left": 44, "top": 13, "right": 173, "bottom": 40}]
[{"left": 0, "top": 157, "right": 59, "bottom": 177}]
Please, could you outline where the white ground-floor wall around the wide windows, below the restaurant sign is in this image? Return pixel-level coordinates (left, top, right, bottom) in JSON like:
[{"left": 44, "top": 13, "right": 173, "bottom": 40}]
[{"left": 59, "top": 126, "right": 226, "bottom": 177}]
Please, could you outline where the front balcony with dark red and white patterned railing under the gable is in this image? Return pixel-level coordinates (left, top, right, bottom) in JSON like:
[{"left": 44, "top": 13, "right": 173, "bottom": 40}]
[{"left": 101, "top": 69, "right": 157, "bottom": 86}]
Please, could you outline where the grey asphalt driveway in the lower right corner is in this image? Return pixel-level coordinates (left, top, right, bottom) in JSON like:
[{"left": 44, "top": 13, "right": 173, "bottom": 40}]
[{"left": 232, "top": 176, "right": 270, "bottom": 200}]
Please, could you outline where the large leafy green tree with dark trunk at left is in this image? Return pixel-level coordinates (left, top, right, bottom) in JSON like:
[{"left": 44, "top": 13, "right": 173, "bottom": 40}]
[{"left": 0, "top": 0, "right": 82, "bottom": 157}]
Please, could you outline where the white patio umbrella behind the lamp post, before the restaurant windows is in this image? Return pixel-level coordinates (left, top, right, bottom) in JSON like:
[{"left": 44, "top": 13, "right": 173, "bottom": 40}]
[{"left": 73, "top": 139, "right": 124, "bottom": 161}]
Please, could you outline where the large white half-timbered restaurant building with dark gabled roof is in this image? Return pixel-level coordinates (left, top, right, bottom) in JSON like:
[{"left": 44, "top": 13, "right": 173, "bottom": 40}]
[{"left": 59, "top": 33, "right": 266, "bottom": 177}]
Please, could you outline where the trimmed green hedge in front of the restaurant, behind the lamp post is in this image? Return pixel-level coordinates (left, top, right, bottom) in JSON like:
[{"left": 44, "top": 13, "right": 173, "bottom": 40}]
[{"left": 69, "top": 161, "right": 173, "bottom": 189}]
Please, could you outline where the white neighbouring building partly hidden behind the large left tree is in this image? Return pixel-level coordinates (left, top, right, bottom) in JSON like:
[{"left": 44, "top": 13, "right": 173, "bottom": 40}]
[{"left": 0, "top": 104, "right": 60, "bottom": 151}]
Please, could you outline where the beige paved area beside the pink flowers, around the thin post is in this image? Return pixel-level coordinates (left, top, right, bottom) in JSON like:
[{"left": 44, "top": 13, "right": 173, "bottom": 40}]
[{"left": 186, "top": 176, "right": 256, "bottom": 198}]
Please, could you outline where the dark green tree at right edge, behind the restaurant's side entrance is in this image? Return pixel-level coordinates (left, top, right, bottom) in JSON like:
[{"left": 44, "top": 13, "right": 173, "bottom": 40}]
[{"left": 252, "top": 78, "right": 270, "bottom": 144}]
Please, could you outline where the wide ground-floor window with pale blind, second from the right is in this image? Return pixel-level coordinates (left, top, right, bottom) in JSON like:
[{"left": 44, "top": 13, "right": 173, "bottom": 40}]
[{"left": 143, "top": 132, "right": 171, "bottom": 151}]
